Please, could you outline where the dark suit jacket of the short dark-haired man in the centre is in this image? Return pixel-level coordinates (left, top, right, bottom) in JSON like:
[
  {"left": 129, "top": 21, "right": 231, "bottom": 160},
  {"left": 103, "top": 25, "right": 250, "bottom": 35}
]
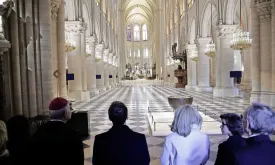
[{"left": 93, "top": 125, "right": 150, "bottom": 165}]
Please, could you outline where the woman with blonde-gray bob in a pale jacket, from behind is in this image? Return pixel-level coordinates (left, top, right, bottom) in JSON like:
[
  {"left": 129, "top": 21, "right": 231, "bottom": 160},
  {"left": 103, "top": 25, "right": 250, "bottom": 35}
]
[{"left": 161, "top": 105, "right": 210, "bottom": 165}]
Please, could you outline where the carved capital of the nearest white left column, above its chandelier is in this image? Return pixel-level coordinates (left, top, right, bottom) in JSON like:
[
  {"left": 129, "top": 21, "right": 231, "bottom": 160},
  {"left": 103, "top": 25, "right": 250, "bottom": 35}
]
[{"left": 65, "top": 21, "right": 87, "bottom": 35}]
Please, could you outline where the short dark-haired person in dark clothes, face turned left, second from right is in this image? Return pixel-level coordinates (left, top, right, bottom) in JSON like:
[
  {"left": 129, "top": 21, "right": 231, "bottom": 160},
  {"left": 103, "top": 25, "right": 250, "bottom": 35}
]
[{"left": 215, "top": 113, "right": 246, "bottom": 165}]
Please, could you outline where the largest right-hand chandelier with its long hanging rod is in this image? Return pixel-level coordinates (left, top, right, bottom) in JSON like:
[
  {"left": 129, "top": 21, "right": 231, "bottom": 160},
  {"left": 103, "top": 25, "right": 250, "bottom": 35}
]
[{"left": 231, "top": 0, "right": 252, "bottom": 51}]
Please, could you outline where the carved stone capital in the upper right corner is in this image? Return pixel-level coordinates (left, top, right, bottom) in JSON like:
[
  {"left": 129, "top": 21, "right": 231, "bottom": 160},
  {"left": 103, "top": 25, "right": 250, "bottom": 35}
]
[{"left": 256, "top": 0, "right": 274, "bottom": 23}]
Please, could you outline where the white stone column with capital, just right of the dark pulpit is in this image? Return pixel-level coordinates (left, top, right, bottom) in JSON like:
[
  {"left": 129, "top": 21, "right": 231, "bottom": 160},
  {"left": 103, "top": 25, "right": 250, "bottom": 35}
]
[{"left": 196, "top": 38, "right": 212, "bottom": 92}]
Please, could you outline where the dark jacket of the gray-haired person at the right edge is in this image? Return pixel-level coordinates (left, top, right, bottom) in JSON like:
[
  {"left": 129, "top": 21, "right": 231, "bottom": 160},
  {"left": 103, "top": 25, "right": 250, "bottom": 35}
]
[{"left": 234, "top": 135, "right": 275, "bottom": 165}]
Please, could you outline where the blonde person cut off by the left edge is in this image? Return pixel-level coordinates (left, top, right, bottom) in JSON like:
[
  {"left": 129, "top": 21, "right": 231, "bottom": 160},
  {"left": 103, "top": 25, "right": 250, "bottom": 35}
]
[{"left": 0, "top": 120, "right": 10, "bottom": 165}]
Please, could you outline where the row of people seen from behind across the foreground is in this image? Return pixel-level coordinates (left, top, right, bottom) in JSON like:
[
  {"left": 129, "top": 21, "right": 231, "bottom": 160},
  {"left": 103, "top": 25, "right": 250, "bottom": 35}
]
[{"left": 0, "top": 97, "right": 275, "bottom": 165}]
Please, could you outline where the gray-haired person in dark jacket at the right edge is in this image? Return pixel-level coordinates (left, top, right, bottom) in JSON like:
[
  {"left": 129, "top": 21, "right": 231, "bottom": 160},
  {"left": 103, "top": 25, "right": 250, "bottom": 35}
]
[{"left": 234, "top": 103, "right": 275, "bottom": 165}]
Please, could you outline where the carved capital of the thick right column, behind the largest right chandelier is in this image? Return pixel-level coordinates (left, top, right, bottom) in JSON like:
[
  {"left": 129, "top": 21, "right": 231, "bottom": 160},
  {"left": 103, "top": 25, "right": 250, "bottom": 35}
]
[{"left": 217, "top": 25, "right": 241, "bottom": 38}]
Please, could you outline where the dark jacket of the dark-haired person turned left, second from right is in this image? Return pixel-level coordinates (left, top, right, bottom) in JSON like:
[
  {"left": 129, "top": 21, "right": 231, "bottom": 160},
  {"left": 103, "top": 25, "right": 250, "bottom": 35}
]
[{"left": 215, "top": 135, "right": 246, "bottom": 165}]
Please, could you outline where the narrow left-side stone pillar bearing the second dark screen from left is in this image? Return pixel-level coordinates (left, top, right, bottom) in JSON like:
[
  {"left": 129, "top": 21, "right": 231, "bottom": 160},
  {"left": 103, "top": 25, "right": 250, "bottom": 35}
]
[{"left": 95, "top": 44, "right": 106, "bottom": 92}]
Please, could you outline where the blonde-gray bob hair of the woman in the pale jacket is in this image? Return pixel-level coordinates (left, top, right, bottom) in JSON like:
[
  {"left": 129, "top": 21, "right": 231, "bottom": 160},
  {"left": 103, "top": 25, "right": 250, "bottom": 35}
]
[{"left": 171, "top": 105, "right": 202, "bottom": 137}]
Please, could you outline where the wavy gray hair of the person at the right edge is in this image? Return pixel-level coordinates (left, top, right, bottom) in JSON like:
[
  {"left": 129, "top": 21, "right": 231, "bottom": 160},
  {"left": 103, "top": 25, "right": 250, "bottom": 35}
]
[{"left": 244, "top": 103, "right": 275, "bottom": 134}]
